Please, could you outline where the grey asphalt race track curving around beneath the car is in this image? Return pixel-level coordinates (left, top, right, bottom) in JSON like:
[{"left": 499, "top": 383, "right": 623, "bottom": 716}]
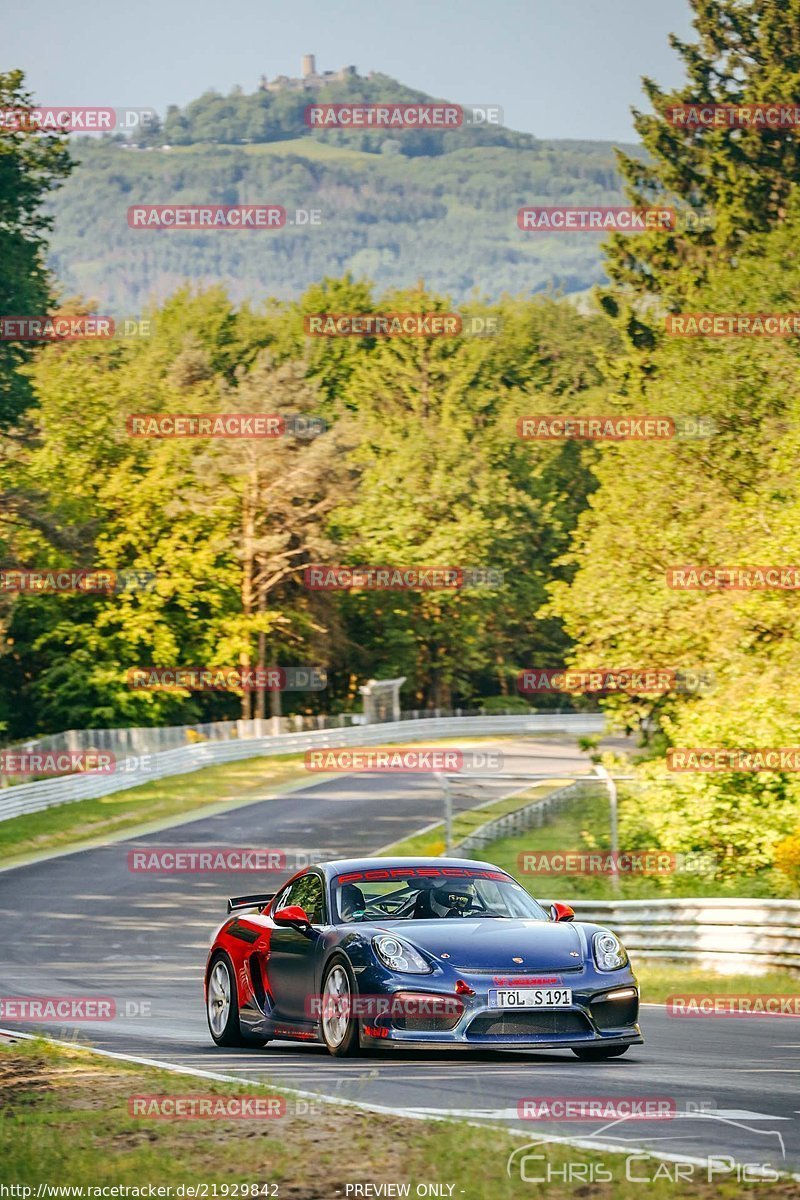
[{"left": 0, "top": 738, "right": 800, "bottom": 1171}]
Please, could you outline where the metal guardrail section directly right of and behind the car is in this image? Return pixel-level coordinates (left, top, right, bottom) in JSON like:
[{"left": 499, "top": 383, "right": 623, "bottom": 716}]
[{"left": 567, "top": 898, "right": 800, "bottom": 974}]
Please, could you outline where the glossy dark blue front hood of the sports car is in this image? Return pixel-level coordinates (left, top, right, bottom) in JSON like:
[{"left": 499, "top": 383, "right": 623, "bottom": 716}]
[{"left": 375, "top": 917, "right": 585, "bottom": 972}]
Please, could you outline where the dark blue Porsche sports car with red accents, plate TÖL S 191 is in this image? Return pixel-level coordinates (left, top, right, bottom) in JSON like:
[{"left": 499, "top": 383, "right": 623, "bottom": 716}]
[{"left": 205, "top": 858, "right": 642, "bottom": 1060}]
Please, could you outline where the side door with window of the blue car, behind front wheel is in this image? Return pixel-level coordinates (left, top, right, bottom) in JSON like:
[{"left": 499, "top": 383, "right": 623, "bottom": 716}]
[{"left": 267, "top": 871, "right": 327, "bottom": 1022}]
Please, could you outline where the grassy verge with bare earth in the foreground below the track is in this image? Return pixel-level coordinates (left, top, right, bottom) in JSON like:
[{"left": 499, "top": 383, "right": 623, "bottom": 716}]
[{"left": 0, "top": 1042, "right": 800, "bottom": 1200}]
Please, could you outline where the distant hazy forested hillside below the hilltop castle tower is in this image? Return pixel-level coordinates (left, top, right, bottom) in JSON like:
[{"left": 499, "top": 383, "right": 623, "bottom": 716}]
[{"left": 50, "top": 80, "right": 630, "bottom": 313}]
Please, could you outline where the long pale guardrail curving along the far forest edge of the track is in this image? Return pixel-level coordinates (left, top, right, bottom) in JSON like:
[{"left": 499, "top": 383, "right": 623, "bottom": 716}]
[{"left": 0, "top": 713, "right": 606, "bottom": 821}]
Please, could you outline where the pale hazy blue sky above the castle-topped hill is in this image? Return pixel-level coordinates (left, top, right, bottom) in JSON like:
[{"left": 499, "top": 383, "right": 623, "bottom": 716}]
[{"left": 0, "top": 0, "right": 691, "bottom": 140}]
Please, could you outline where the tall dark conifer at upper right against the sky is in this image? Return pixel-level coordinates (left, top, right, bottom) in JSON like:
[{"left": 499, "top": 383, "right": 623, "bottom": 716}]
[{"left": 606, "top": 0, "right": 800, "bottom": 307}]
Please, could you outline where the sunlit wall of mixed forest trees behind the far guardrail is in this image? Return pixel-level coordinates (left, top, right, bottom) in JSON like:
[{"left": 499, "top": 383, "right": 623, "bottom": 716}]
[{"left": 0, "top": 277, "right": 616, "bottom": 737}]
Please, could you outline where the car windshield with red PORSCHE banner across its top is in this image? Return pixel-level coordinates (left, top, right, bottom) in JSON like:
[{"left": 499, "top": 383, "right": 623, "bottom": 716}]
[{"left": 333, "top": 866, "right": 548, "bottom": 924}]
